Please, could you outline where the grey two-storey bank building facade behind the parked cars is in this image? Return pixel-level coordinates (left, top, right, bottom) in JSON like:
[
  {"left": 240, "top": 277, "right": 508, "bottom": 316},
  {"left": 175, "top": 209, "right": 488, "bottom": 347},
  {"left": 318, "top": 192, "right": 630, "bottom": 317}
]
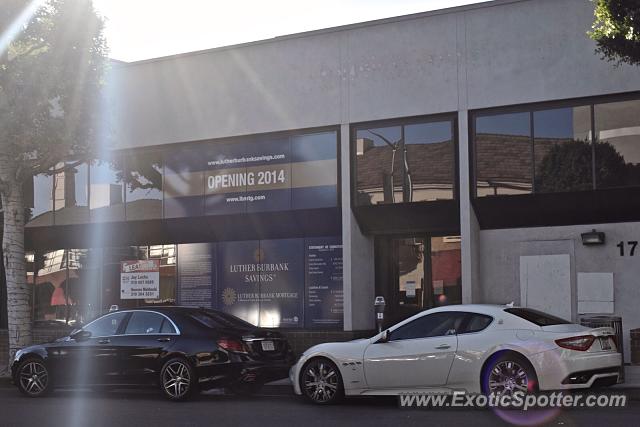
[{"left": 0, "top": 0, "right": 640, "bottom": 360}]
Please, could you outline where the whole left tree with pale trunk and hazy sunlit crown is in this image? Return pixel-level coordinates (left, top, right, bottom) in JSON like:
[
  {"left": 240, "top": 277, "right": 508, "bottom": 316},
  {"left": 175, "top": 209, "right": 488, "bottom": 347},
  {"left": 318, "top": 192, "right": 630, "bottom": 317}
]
[{"left": 0, "top": 0, "right": 107, "bottom": 362}]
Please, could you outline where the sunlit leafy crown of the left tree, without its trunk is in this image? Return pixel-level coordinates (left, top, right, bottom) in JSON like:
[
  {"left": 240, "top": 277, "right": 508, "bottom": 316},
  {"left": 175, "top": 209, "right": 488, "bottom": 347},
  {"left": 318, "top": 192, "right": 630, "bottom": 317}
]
[{"left": 0, "top": 0, "right": 106, "bottom": 184}]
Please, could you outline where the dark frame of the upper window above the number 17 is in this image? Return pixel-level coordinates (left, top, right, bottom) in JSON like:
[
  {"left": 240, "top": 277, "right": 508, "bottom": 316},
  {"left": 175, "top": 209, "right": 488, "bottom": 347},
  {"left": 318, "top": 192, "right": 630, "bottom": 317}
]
[{"left": 467, "top": 91, "right": 640, "bottom": 199}]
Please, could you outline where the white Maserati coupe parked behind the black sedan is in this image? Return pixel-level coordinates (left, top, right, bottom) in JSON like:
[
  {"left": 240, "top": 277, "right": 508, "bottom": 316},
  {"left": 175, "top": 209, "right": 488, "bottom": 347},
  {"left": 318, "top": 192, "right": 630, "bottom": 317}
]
[{"left": 290, "top": 305, "right": 621, "bottom": 404}]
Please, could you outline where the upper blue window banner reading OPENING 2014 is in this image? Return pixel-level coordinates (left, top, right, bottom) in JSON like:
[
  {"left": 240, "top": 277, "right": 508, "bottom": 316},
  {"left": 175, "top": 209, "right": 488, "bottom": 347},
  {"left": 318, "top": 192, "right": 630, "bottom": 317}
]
[{"left": 164, "top": 131, "right": 338, "bottom": 217}]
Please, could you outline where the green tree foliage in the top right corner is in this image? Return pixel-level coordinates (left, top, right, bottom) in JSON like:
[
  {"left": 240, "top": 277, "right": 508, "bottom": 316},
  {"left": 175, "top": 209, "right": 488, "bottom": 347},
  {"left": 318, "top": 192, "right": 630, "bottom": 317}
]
[{"left": 589, "top": 0, "right": 640, "bottom": 65}]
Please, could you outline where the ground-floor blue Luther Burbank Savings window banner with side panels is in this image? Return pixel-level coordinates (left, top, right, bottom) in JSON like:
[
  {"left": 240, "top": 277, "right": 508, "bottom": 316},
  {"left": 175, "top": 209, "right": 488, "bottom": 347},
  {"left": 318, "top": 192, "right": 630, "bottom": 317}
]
[{"left": 178, "top": 237, "right": 343, "bottom": 329}]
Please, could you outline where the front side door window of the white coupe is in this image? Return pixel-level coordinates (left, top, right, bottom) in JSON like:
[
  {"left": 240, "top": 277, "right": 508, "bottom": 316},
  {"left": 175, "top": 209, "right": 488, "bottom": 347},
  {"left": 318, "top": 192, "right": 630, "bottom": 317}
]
[{"left": 390, "top": 311, "right": 466, "bottom": 341}]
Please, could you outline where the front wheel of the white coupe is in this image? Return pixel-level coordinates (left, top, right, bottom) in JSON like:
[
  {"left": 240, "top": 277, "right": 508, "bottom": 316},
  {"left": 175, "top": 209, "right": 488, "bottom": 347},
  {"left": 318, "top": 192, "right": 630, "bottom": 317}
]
[{"left": 300, "top": 358, "right": 344, "bottom": 405}]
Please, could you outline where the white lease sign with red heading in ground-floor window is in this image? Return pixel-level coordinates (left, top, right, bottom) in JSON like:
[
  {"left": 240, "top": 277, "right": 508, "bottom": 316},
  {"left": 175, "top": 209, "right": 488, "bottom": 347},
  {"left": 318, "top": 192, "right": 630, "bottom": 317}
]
[{"left": 120, "top": 259, "right": 160, "bottom": 299}]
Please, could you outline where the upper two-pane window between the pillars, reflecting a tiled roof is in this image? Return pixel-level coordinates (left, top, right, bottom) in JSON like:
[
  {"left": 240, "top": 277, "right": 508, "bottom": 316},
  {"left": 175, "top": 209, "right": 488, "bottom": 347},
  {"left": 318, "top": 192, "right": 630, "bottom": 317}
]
[{"left": 353, "top": 119, "right": 456, "bottom": 206}]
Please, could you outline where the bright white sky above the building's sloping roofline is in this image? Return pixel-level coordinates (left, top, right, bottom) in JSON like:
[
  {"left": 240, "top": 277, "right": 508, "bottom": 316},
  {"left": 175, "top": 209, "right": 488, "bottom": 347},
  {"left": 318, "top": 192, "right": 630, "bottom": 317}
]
[{"left": 93, "top": 0, "right": 484, "bottom": 62}]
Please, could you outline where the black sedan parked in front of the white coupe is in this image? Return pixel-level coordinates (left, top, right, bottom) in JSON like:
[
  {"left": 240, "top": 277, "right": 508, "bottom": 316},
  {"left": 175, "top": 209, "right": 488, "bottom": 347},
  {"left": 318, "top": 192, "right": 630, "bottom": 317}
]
[{"left": 11, "top": 307, "right": 294, "bottom": 400}]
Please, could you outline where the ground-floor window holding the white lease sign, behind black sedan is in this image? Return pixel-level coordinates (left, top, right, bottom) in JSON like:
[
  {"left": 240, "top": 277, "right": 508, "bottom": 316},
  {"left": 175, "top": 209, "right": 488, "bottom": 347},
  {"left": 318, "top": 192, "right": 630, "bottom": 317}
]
[{"left": 26, "top": 245, "right": 176, "bottom": 325}]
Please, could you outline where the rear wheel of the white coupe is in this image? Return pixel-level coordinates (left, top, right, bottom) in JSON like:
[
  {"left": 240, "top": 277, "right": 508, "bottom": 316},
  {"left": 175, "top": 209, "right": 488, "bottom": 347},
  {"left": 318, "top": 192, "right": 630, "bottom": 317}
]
[{"left": 480, "top": 352, "right": 538, "bottom": 395}]
